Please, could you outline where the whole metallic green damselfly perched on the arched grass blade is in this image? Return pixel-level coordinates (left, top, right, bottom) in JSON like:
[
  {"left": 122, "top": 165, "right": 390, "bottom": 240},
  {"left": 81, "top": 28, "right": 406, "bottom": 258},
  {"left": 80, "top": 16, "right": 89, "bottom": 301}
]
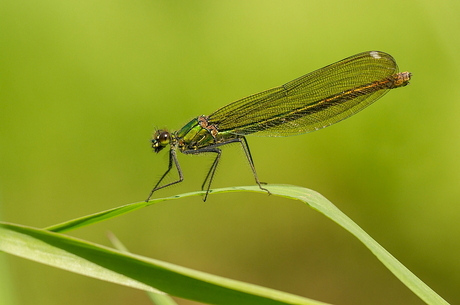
[{"left": 147, "top": 51, "right": 411, "bottom": 201}]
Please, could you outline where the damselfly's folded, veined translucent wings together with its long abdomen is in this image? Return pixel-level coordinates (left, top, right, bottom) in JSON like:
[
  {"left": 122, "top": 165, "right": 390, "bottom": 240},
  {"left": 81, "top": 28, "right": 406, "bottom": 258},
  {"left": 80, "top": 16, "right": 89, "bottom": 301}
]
[{"left": 208, "top": 51, "right": 410, "bottom": 136}]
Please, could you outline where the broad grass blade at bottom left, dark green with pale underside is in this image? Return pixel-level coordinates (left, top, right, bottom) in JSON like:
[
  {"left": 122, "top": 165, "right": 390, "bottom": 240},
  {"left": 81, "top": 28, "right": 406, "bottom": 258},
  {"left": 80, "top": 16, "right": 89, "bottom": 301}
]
[{"left": 0, "top": 223, "right": 325, "bottom": 305}]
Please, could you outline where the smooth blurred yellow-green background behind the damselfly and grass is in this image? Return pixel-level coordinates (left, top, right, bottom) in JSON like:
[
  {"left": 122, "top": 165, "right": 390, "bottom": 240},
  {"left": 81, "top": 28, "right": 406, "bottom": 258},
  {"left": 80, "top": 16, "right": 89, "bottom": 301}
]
[{"left": 0, "top": 0, "right": 460, "bottom": 305}]
